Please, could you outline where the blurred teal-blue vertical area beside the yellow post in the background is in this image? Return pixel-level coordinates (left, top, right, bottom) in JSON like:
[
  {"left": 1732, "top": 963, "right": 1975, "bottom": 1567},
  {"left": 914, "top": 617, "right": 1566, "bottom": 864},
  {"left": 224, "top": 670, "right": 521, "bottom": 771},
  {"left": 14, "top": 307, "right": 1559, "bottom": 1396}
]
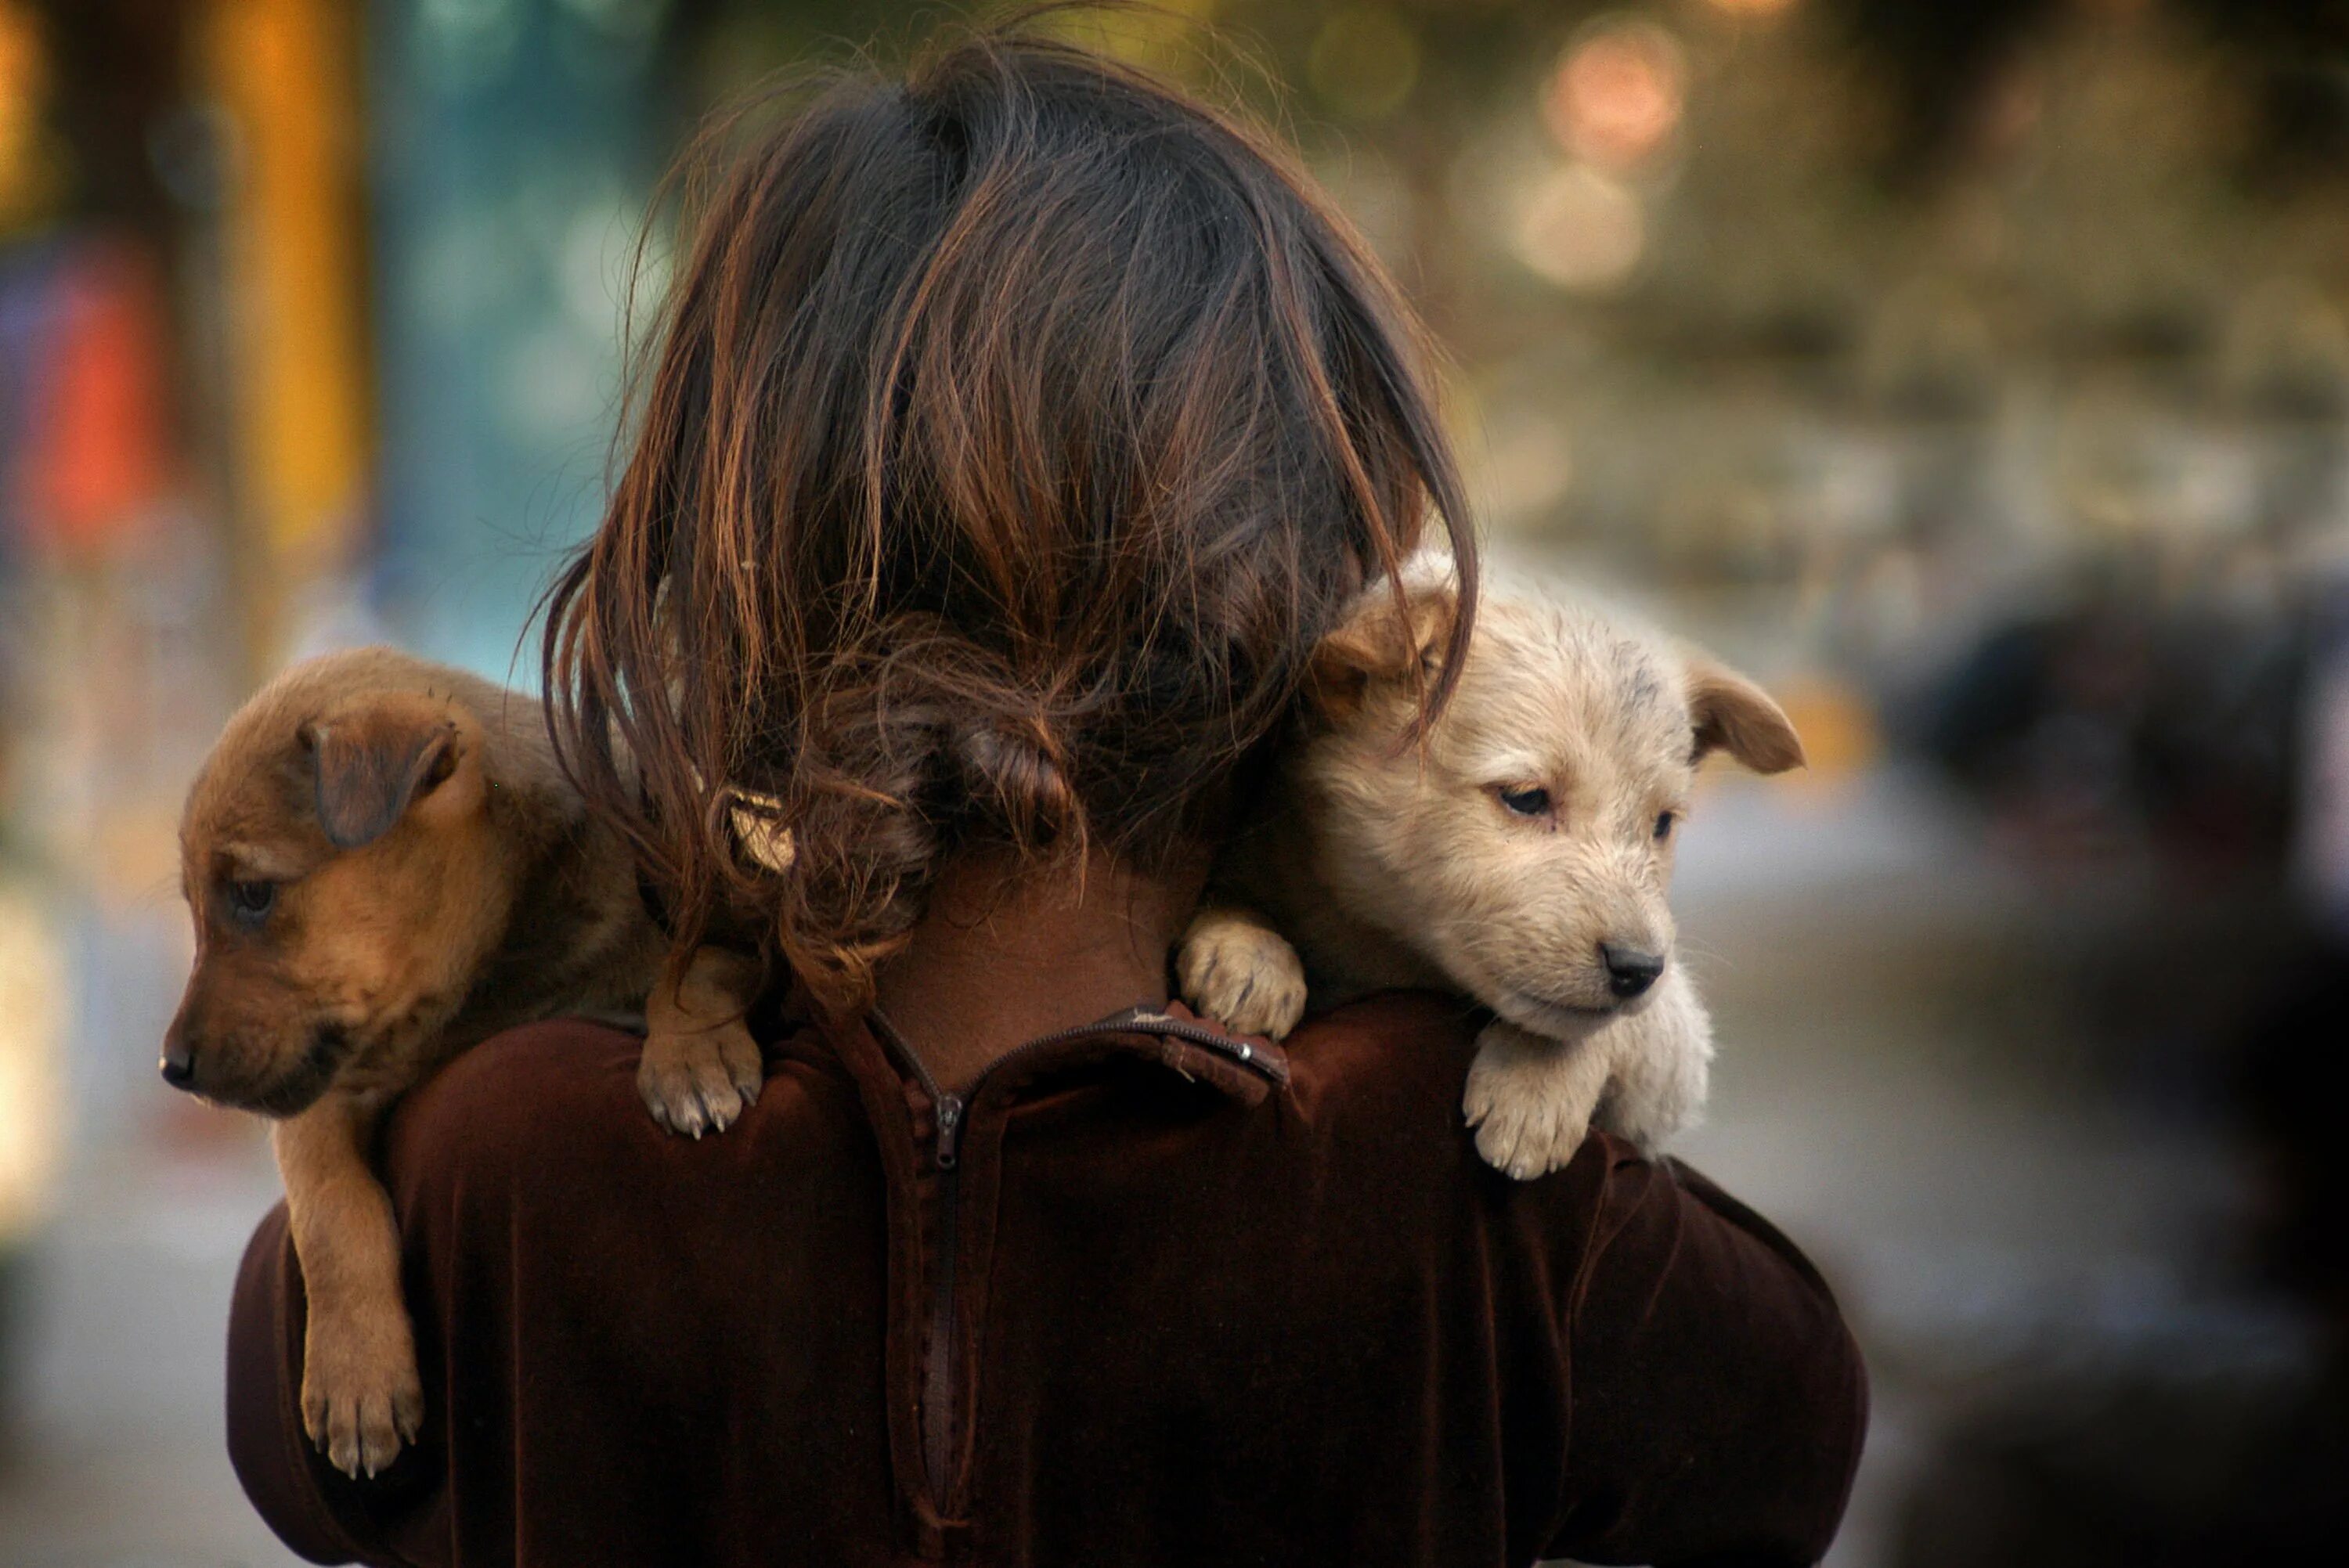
[{"left": 366, "top": 0, "right": 667, "bottom": 679}]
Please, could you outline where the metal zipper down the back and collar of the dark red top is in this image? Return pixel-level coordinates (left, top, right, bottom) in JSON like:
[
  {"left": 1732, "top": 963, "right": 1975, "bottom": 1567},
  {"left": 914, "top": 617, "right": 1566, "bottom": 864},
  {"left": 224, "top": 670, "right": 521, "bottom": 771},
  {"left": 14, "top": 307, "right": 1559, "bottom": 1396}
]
[{"left": 874, "top": 1007, "right": 1287, "bottom": 1514}]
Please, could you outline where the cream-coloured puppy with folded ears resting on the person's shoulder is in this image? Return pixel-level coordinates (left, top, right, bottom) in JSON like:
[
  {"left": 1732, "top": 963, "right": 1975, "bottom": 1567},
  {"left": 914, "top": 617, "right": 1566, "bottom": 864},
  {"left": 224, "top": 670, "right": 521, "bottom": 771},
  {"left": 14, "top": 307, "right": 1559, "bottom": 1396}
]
[{"left": 1177, "top": 585, "right": 1802, "bottom": 1181}]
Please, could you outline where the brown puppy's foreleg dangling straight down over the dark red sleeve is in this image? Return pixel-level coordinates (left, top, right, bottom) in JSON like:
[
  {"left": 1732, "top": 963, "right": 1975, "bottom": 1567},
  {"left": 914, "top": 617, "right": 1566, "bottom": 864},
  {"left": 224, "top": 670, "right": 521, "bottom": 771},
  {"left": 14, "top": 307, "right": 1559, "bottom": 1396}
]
[{"left": 275, "top": 1094, "right": 425, "bottom": 1476}]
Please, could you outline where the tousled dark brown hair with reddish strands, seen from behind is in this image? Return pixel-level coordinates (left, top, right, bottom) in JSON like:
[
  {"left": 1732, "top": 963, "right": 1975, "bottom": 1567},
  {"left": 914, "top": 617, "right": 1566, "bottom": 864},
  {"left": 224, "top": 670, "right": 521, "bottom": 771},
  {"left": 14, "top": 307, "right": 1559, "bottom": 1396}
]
[{"left": 545, "top": 31, "right": 1475, "bottom": 1009}]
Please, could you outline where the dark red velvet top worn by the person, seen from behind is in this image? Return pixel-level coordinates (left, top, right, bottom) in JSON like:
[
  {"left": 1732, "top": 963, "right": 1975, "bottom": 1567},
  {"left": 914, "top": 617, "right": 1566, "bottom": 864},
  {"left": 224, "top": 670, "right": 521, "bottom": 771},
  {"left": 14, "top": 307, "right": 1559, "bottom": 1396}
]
[{"left": 228, "top": 995, "right": 1867, "bottom": 1568}]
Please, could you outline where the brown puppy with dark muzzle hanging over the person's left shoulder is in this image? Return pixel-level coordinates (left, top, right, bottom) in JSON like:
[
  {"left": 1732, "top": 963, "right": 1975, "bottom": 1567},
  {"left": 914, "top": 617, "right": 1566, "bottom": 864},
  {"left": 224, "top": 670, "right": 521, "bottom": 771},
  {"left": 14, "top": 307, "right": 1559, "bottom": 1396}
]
[{"left": 162, "top": 648, "right": 763, "bottom": 1474}]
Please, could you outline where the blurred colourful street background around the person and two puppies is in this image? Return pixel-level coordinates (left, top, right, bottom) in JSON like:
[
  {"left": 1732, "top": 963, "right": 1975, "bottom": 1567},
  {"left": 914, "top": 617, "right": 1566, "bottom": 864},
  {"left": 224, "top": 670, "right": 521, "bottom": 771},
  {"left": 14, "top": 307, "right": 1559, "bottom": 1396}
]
[{"left": 0, "top": 0, "right": 2349, "bottom": 1568}]
